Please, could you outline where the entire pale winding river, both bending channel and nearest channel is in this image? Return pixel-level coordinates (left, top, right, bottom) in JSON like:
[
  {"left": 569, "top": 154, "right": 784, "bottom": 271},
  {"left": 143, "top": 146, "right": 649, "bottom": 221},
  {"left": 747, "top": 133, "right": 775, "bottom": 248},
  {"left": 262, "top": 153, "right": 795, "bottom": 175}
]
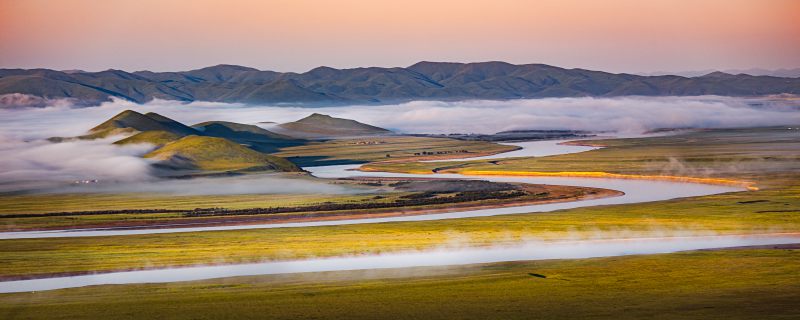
[{"left": 0, "top": 141, "right": 800, "bottom": 293}]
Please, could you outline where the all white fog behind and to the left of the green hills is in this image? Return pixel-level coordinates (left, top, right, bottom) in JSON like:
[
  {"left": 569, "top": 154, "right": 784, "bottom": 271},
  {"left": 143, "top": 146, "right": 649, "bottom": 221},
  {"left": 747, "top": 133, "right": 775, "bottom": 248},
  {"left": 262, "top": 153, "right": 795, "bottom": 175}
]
[{"left": 0, "top": 96, "right": 800, "bottom": 192}]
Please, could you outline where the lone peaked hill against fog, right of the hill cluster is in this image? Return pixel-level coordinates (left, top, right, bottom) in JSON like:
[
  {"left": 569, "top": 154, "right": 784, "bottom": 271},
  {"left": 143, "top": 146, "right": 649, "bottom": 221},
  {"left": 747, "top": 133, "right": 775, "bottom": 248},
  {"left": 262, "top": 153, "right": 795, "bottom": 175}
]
[{"left": 276, "top": 113, "right": 392, "bottom": 138}]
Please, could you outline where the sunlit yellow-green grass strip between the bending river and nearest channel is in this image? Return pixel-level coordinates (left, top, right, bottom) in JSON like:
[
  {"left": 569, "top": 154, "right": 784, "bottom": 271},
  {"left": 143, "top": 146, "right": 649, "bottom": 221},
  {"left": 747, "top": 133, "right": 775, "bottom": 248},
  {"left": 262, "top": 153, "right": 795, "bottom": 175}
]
[{"left": 0, "top": 182, "right": 800, "bottom": 277}]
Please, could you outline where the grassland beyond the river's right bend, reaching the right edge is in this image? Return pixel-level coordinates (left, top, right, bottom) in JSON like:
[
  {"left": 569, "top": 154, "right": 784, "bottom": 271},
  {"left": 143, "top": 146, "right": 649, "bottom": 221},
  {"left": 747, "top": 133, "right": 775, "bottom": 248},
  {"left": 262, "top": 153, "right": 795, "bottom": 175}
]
[{"left": 364, "top": 127, "right": 800, "bottom": 187}]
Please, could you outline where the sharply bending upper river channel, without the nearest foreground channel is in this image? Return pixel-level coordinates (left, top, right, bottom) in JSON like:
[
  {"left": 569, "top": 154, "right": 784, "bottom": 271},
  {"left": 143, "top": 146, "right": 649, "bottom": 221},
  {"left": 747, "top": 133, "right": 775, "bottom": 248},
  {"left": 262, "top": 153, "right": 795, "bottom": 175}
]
[{"left": 0, "top": 141, "right": 744, "bottom": 239}]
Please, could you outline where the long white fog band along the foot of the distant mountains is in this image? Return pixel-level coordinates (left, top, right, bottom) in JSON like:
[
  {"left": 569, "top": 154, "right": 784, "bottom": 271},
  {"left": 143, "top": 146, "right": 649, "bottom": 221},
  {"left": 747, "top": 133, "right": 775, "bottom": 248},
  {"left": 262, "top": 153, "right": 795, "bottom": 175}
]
[{"left": 0, "top": 96, "right": 800, "bottom": 139}]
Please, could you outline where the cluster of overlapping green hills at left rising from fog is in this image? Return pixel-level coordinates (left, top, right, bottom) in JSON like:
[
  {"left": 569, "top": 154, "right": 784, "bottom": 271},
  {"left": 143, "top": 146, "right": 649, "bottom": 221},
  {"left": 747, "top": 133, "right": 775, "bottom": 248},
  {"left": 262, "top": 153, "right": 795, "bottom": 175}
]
[{"left": 49, "top": 110, "right": 303, "bottom": 172}]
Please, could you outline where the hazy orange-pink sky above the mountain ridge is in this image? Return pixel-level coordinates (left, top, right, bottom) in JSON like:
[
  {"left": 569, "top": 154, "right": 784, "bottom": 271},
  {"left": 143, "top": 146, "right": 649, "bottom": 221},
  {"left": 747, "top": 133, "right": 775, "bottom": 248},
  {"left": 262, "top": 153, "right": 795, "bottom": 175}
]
[{"left": 0, "top": 0, "right": 800, "bottom": 73}]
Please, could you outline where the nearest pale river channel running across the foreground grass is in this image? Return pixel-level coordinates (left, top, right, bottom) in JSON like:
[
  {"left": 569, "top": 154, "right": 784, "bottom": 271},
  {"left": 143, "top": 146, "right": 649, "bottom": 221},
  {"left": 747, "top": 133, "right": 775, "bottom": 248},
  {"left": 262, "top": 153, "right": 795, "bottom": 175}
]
[{"left": 0, "top": 233, "right": 798, "bottom": 293}]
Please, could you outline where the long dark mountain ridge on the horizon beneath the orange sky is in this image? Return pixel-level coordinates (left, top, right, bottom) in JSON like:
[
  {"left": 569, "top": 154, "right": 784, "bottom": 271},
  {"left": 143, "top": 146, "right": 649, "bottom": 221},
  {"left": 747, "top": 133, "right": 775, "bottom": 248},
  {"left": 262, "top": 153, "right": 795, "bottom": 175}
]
[{"left": 0, "top": 61, "right": 800, "bottom": 106}]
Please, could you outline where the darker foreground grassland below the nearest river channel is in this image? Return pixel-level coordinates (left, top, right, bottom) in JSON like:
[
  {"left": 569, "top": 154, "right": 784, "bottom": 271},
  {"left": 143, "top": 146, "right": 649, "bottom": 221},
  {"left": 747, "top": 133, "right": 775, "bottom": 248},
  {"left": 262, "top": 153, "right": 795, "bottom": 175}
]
[{"left": 0, "top": 249, "right": 800, "bottom": 319}]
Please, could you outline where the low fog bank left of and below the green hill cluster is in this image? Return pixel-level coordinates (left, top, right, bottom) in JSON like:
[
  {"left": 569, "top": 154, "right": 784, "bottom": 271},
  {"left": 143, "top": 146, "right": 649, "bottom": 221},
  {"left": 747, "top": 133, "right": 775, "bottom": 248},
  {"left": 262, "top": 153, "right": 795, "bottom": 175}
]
[{"left": 0, "top": 137, "right": 362, "bottom": 195}]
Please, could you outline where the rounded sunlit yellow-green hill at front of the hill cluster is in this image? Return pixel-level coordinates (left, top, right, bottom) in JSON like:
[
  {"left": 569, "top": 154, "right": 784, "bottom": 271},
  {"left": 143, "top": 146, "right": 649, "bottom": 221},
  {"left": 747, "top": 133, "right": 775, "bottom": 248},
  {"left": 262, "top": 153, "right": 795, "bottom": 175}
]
[{"left": 145, "top": 135, "right": 301, "bottom": 172}]
